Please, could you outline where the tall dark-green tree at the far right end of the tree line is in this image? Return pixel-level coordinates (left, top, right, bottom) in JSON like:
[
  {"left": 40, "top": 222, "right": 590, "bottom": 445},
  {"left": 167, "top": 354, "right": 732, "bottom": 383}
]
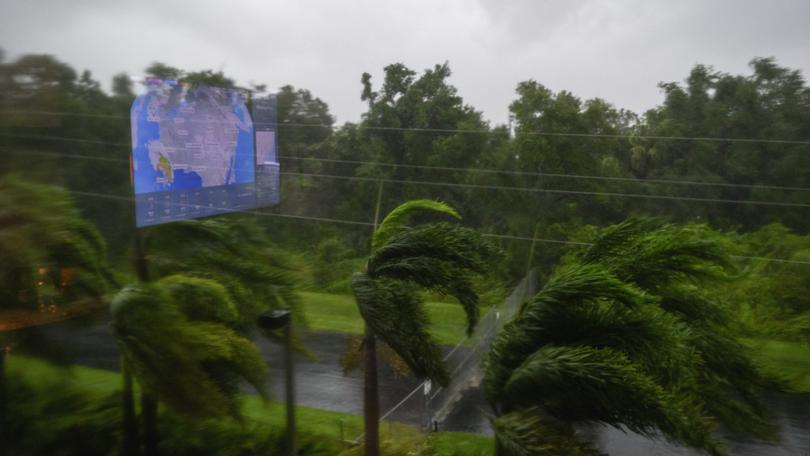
[{"left": 634, "top": 58, "right": 810, "bottom": 230}]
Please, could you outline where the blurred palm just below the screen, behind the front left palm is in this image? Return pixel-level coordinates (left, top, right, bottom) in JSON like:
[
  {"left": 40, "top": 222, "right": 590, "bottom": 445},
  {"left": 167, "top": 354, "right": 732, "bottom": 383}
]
[{"left": 116, "top": 216, "right": 303, "bottom": 454}]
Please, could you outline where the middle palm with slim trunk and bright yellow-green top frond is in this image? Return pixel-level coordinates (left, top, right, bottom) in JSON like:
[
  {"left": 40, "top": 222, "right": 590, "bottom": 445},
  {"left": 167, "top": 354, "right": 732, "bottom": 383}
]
[{"left": 352, "top": 200, "right": 497, "bottom": 456}]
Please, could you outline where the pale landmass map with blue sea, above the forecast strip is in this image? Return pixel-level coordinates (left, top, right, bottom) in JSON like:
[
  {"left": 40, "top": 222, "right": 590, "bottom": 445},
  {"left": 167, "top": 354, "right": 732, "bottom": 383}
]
[{"left": 131, "top": 82, "right": 255, "bottom": 194}]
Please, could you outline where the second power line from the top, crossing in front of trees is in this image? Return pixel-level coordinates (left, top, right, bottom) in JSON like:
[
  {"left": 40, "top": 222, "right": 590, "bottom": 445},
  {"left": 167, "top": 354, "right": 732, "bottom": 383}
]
[{"left": 0, "top": 133, "right": 810, "bottom": 196}]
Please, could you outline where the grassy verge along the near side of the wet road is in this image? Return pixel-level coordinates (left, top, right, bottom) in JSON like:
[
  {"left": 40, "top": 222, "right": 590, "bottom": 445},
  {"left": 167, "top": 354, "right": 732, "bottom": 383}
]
[{"left": 7, "top": 355, "right": 492, "bottom": 456}]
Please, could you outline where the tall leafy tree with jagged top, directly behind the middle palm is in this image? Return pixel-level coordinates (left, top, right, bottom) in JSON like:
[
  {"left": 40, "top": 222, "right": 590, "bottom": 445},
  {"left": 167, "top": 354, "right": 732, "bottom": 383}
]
[{"left": 359, "top": 63, "right": 489, "bottom": 216}]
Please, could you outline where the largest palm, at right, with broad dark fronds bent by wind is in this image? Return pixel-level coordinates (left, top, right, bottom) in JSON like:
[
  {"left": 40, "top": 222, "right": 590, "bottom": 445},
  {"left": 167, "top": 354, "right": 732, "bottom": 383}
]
[{"left": 484, "top": 219, "right": 773, "bottom": 455}]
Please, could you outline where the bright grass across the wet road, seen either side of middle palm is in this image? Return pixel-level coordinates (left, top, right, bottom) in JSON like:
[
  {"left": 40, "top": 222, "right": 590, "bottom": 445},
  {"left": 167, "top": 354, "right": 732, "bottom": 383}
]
[{"left": 301, "top": 292, "right": 467, "bottom": 345}]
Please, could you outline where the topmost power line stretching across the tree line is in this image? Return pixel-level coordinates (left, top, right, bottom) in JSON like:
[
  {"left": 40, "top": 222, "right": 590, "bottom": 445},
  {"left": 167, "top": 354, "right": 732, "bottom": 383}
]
[{"left": 0, "top": 110, "right": 810, "bottom": 145}]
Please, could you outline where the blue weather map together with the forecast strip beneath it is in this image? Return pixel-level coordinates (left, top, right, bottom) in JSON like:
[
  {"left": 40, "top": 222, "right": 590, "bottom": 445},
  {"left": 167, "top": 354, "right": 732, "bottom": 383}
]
[{"left": 130, "top": 80, "right": 258, "bottom": 226}]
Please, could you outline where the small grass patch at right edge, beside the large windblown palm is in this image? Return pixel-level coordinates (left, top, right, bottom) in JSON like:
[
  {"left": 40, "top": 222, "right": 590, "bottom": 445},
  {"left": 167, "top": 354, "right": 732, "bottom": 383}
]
[{"left": 744, "top": 339, "right": 810, "bottom": 392}]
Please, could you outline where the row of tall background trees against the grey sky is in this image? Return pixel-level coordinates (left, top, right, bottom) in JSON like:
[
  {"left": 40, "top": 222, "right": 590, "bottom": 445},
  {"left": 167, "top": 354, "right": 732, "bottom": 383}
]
[{"left": 0, "top": 55, "right": 810, "bottom": 276}]
